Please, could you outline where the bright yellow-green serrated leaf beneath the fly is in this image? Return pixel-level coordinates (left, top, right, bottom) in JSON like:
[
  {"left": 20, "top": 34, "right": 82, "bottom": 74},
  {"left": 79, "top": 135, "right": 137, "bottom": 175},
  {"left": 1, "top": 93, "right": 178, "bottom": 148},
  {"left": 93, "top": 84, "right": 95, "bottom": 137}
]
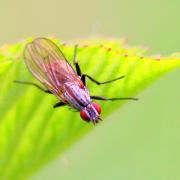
[{"left": 0, "top": 39, "right": 180, "bottom": 180}]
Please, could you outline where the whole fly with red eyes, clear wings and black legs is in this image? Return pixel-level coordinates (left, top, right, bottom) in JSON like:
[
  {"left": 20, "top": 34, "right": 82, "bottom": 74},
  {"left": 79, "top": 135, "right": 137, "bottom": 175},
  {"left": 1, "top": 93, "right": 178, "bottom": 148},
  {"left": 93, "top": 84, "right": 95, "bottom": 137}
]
[{"left": 15, "top": 38, "right": 137, "bottom": 124}]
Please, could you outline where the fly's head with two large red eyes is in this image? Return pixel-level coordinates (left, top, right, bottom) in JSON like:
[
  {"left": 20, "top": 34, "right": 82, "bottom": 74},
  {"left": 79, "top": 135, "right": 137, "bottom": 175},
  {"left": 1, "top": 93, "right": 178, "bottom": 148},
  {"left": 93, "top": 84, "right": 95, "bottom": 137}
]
[{"left": 80, "top": 102, "right": 101, "bottom": 124}]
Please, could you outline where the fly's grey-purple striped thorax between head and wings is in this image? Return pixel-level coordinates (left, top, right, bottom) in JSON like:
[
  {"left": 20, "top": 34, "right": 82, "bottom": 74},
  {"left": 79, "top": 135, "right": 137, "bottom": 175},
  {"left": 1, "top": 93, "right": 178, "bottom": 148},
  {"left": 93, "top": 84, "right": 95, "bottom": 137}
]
[{"left": 63, "top": 82, "right": 91, "bottom": 110}]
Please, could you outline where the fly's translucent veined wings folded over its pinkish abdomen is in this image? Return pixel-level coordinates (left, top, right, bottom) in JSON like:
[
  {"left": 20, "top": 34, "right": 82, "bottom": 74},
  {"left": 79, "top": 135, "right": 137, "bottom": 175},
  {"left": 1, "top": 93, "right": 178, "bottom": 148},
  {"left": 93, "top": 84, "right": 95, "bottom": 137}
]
[{"left": 24, "top": 38, "right": 82, "bottom": 96}]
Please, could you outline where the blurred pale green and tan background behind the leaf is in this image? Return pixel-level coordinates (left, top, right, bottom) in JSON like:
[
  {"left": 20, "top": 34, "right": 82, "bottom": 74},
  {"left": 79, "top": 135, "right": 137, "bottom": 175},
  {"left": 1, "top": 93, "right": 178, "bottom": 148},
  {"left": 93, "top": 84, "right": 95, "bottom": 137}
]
[{"left": 0, "top": 0, "right": 180, "bottom": 180}]
